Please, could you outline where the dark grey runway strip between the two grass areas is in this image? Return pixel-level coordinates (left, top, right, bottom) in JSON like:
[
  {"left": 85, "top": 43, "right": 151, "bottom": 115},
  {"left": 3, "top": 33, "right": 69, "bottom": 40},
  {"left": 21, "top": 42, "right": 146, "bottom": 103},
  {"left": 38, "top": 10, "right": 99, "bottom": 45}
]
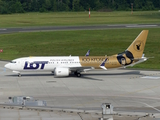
[{"left": 0, "top": 24, "right": 160, "bottom": 34}]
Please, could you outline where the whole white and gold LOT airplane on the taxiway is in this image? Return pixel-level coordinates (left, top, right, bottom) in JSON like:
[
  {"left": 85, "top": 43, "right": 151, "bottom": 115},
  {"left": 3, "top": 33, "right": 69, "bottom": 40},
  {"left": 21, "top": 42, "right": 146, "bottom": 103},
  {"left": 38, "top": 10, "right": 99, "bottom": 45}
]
[{"left": 5, "top": 30, "right": 148, "bottom": 77}]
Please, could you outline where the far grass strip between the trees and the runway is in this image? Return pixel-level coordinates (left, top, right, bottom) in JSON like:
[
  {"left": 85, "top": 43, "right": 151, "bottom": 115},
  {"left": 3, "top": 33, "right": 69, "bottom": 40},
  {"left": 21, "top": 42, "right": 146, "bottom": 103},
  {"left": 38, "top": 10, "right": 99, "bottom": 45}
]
[{"left": 0, "top": 11, "right": 160, "bottom": 28}]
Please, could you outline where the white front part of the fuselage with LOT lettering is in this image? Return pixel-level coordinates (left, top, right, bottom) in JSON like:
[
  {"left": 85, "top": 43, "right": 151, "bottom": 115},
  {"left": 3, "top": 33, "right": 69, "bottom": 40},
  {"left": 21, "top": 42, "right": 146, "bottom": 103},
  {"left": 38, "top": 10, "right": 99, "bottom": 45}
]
[{"left": 5, "top": 56, "right": 81, "bottom": 71}]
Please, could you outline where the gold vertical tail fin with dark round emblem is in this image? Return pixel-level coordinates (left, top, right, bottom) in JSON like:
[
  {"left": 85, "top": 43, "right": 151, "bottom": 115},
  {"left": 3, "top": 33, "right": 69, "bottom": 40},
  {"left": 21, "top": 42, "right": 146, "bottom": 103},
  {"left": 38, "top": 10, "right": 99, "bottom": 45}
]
[{"left": 127, "top": 30, "right": 148, "bottom": 58}]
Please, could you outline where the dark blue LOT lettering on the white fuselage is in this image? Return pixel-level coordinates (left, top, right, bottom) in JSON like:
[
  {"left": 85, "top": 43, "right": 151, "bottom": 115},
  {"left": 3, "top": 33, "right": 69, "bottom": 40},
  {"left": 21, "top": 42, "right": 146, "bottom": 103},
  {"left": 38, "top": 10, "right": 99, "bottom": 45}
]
[{"left": 23, "top": 61, "right": 48, "bottom": 70}]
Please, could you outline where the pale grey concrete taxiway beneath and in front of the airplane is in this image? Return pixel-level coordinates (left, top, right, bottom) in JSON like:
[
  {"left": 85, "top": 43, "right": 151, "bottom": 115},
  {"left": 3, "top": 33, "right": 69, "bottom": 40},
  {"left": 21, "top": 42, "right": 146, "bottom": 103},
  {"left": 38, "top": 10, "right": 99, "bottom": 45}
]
[{"left": 0, "top": 61, "right": 160, "bottom": 119}]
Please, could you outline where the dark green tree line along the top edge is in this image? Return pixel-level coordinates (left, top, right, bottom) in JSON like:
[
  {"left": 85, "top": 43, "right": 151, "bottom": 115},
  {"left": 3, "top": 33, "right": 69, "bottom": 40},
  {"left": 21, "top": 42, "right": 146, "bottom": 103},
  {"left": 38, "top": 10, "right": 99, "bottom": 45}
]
[{"left": 0, "top": 0, "right": 160, "bottom": 14}]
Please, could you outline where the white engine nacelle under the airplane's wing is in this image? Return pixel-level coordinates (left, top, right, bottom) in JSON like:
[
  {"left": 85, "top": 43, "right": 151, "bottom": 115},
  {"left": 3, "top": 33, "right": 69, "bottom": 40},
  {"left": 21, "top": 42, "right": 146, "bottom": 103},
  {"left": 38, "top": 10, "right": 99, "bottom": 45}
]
[{"left": 54, "top": 68, "right": 69, "bottom": 77}]
